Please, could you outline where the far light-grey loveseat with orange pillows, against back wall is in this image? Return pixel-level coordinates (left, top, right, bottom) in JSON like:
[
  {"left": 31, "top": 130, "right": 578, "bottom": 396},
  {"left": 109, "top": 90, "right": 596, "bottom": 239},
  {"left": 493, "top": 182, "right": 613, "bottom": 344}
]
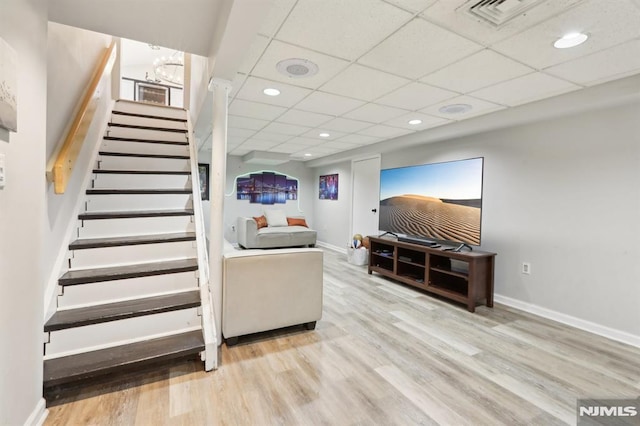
[{"left": 237, "top": 217, "right": 317, "bottom": 248}]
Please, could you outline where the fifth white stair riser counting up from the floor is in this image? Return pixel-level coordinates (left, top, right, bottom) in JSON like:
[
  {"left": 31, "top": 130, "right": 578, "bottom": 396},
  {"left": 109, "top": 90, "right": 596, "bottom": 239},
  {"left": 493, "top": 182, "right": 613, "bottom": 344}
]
[{"left": 86, "top": 194, "right": 192, "bottom": 212}]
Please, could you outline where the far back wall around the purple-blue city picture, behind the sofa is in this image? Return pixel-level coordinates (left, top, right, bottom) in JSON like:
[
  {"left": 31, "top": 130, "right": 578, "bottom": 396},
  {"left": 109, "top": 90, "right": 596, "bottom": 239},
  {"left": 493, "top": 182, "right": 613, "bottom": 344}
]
[{"left": 198, "top": 155, "right": 317, "bottom": 243}]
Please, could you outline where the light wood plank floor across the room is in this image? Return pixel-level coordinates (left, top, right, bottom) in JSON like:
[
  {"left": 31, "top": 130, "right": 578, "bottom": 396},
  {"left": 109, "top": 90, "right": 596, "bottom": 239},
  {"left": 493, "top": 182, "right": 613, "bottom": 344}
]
[{"left": 46, "top": 250, "right": 640, "bottom": 426}]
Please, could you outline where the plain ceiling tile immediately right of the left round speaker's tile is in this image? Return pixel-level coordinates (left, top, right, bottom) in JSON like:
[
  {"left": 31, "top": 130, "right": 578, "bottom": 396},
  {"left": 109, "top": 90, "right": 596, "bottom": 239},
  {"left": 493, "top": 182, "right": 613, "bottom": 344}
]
[{"left": 321, "top": 64, "right": 409, "bottom": 101}]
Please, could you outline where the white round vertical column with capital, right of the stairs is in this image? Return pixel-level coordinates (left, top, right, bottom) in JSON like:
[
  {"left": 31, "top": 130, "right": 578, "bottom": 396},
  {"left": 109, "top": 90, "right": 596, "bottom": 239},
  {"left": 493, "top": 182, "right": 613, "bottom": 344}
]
[{"left": 209, "top": 78, "right": 231, "bottom": 338}]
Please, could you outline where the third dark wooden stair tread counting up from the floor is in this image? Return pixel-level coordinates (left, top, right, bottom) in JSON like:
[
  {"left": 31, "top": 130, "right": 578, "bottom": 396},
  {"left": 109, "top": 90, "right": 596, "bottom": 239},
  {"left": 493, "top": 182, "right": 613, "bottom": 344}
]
[{"left": 58, "top": 258, "right": 198, "bottom": 286}]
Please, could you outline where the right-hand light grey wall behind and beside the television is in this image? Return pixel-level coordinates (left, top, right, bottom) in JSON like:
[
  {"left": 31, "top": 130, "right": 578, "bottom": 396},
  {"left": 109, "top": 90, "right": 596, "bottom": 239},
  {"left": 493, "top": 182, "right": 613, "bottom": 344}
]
[{"left": 382, "top": 104, "right": 640, "bottom": 342}]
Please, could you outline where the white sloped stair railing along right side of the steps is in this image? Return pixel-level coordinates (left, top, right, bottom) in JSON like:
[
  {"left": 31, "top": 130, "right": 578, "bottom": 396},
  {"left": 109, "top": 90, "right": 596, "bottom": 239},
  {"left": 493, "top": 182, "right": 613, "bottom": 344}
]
[{"left": 187, "top": 114, "right": 218, "bottom": 371}]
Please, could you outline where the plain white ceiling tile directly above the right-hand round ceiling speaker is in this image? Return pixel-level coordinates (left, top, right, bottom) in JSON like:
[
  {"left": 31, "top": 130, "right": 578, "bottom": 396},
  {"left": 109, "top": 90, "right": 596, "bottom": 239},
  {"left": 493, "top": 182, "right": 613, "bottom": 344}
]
[{"left": 420, "top": 49, "right": 535, "bottom": 93}]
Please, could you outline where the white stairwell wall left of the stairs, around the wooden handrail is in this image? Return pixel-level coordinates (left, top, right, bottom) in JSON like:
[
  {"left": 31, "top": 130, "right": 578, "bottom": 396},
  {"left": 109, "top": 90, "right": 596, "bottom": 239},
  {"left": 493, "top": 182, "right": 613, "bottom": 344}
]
[{"left": 43, "top": 22, "right": 111, "bottom": 313}]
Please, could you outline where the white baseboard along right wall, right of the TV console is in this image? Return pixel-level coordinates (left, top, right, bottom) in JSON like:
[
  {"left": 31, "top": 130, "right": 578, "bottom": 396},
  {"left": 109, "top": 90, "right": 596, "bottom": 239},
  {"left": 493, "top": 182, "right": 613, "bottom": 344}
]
[{"left": 494, "top": 294, "right": 640, "bottom": 348}]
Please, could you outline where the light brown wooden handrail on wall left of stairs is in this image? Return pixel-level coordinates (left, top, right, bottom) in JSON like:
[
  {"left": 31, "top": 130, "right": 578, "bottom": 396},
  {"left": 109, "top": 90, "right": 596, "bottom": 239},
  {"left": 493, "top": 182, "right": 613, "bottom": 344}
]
[{"left": 47, "top": 41, "right": 116, "bottom": 194}]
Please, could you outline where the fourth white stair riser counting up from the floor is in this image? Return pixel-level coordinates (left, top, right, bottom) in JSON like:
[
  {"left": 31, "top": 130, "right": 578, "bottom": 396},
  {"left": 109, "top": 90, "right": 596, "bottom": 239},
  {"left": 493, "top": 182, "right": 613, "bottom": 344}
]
[{"left": 78, "top": 216, "right": 195, "bottom": 238}]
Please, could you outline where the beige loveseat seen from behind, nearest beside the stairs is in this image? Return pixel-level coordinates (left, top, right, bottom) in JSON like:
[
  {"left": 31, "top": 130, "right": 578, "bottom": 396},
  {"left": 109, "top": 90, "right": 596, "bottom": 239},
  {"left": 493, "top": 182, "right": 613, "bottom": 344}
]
[{"left": 222, "top": 248, "right": 323, "bottom": 345}]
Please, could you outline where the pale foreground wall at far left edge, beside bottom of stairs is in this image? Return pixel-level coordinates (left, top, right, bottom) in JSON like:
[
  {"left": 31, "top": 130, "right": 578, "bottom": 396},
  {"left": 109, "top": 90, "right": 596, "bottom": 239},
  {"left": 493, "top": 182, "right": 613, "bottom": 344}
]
[{"left": 0, "top": 0, "right": 48, "bottom": 425}]
